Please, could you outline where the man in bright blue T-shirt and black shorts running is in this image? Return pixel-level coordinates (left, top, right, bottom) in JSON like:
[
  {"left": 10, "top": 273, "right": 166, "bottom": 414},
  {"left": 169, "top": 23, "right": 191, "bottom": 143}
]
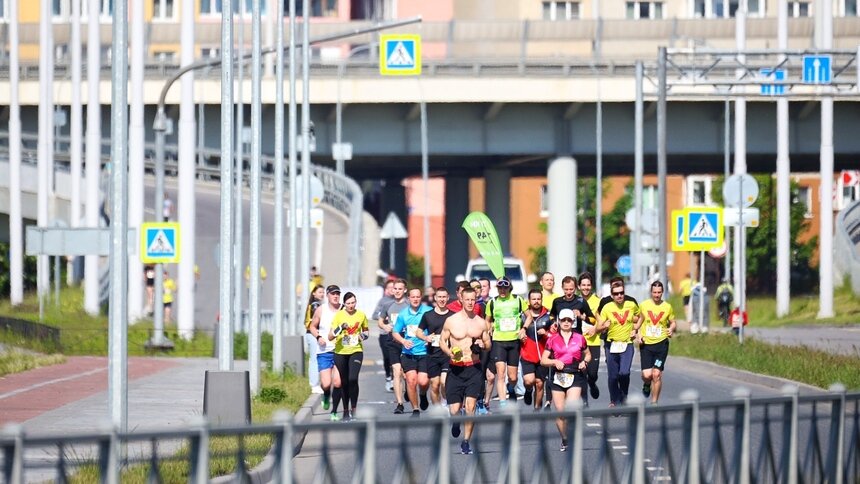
[{"left": 391, "top": 287, "right": 431, "bottom": 417}]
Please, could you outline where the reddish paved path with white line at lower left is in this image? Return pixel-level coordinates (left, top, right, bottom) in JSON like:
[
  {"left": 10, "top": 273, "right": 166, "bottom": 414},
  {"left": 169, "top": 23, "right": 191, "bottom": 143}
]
[{"left": 0, "top": 356, "right": 179, "bottom": 426}]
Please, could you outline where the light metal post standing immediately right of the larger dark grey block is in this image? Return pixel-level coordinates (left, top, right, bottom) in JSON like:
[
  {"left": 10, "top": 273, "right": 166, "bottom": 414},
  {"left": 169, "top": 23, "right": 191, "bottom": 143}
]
[{"left": 248, "top": 0, "right": 262, "bottom": 395}]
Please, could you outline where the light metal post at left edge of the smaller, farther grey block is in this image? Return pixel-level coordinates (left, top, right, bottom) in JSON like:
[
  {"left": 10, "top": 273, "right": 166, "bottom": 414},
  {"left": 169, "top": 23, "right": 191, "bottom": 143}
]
[{"left": 272, "top": 1, "right": 288, "bottom": 366}]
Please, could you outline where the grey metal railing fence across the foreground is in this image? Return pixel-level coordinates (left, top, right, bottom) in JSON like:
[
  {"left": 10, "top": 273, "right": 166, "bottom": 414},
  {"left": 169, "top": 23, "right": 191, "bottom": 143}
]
[{"left": 0, "top": 386, "right": 860, "bottom": 484}]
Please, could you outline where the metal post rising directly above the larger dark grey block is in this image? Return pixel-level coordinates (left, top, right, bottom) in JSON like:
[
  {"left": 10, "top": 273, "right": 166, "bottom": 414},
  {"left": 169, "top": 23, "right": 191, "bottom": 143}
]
[{"left": 218, "top": 0, "right": 235, "bottom": 371}]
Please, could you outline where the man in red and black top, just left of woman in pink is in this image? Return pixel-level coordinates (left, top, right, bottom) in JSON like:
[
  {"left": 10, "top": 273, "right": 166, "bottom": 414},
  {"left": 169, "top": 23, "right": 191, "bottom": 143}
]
[{"left": 520, "top": 289, "right": 550, "bottom": 410}]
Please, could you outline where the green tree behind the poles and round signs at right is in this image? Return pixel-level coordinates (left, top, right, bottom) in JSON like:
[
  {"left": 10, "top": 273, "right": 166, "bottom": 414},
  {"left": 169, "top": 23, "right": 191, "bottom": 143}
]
[{"left": 711, "top": 175, "right": 818, "bottom": 294}]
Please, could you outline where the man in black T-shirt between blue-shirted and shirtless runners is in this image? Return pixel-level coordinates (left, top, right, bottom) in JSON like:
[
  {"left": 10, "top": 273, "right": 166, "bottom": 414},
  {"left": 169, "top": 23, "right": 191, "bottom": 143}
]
[{"left": 415, "top": 286, "right": 455, "bottom": 405}]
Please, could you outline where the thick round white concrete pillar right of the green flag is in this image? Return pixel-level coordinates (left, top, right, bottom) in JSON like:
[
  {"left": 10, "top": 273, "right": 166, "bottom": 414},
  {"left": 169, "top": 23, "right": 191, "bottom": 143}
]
[{"left": 546, "top": 157, "right": 576, "bottom": 280}]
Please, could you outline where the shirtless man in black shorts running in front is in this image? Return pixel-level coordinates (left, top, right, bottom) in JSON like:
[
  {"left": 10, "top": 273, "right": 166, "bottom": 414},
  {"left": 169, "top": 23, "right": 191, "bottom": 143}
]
[{"left": 439, "top": 288, "right": 492, "bottom": 455}]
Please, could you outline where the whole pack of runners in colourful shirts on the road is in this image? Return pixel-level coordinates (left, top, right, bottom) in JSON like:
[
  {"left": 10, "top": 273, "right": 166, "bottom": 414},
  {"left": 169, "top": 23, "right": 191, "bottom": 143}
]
[{"left": 309, "top": 272, "right": 675, "bottom": 454}]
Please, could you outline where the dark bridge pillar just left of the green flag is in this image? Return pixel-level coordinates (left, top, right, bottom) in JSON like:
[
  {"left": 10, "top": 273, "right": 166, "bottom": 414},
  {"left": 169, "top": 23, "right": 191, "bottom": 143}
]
[{"left": 445, "top": 176, "right": 469, "bottom": 292}]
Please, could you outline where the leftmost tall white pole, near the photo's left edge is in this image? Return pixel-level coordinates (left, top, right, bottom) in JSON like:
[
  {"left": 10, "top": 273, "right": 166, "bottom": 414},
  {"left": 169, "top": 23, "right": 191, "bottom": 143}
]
[{"left": 9, "top": 2, "right": 24, "bottom": 306}]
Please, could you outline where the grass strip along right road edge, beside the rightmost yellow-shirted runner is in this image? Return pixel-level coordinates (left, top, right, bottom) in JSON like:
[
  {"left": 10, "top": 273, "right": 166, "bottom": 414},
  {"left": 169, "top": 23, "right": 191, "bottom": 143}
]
[{"left": 670, "top": 333, "right": 860, "bottom": 391}]
